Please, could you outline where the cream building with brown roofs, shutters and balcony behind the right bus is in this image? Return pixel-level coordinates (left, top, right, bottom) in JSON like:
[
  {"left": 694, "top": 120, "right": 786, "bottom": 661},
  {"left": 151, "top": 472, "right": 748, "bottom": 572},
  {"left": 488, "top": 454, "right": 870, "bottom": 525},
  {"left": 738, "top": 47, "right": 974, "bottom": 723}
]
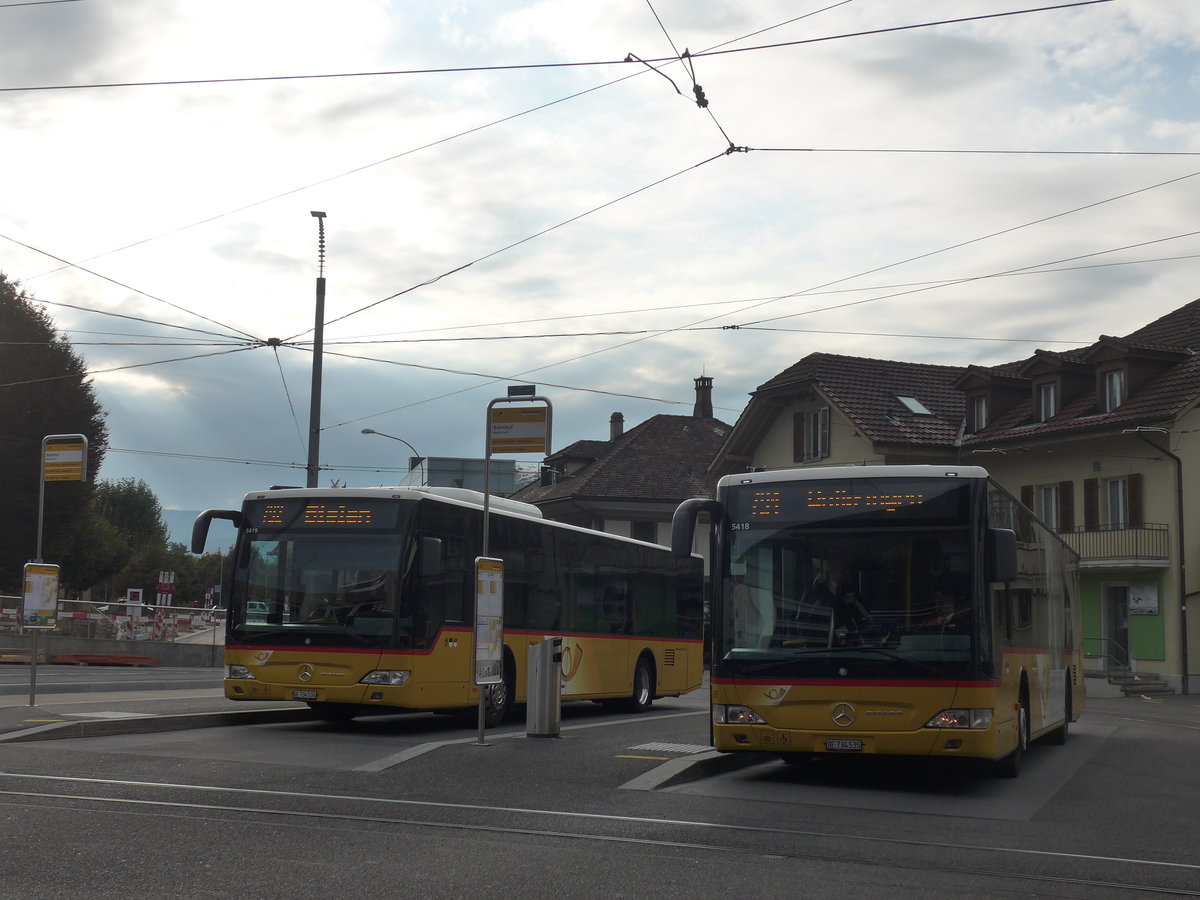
[{"left": 710, "top": 301, "right": 1200, "bottom": 692}]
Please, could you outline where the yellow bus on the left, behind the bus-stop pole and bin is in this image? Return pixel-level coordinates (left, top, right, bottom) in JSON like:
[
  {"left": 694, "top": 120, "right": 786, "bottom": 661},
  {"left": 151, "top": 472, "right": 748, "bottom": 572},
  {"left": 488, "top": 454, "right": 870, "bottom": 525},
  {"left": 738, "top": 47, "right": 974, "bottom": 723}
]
[{"left": 192, "top": 487, "right": 703, "bottom": 727}]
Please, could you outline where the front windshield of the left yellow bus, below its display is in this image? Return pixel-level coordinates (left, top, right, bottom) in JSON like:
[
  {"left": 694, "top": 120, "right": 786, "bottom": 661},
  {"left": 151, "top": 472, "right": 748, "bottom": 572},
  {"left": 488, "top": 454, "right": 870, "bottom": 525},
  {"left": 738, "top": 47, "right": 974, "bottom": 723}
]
[{"left": 229, "top": 530, "right": 413, "bottom": 647}]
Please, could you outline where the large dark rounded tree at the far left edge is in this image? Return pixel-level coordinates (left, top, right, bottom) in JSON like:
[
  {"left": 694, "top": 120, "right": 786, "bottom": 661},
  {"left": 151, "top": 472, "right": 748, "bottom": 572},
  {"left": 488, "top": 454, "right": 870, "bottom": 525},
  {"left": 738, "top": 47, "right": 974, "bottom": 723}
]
[{"left": 0, "top": 274, "right": 108, "bottom": 594}]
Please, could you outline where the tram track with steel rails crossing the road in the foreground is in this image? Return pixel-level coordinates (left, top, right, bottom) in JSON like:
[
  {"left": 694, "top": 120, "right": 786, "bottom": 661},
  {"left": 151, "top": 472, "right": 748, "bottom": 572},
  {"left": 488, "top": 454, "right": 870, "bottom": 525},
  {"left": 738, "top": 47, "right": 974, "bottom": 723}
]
[{"left": 0, "top": 773, "right": 1200, "bottom": 899}]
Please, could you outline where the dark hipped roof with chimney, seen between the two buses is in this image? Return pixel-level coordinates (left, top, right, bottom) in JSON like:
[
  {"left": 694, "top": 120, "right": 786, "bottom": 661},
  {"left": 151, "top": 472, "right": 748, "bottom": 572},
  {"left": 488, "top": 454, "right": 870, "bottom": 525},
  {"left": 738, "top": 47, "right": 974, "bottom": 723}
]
[{"left": 512, "top": 415, "right": 730, "bottom": 503}]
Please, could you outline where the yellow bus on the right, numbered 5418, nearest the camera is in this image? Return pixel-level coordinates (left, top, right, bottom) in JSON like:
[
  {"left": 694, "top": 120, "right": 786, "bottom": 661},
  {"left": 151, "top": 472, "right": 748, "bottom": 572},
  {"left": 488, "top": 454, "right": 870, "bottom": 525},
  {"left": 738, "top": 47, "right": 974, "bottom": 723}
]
[{"left": 672, "top": 466, "right": 1084, "bottom": 778}]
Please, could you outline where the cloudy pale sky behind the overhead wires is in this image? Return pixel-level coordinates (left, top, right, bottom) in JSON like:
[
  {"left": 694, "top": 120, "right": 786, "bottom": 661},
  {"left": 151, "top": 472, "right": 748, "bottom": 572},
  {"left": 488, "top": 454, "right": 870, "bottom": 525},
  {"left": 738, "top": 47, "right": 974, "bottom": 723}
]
[{"left": 0, "top": 0, "right": 1200, "bottom": 525}]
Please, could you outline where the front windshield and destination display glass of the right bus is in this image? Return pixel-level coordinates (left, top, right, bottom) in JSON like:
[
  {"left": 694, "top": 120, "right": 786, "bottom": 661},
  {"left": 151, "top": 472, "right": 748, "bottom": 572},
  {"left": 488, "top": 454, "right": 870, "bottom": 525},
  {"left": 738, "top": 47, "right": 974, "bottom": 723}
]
[{"left": 716, "top": 481, "right": 989, "bottom": 679}]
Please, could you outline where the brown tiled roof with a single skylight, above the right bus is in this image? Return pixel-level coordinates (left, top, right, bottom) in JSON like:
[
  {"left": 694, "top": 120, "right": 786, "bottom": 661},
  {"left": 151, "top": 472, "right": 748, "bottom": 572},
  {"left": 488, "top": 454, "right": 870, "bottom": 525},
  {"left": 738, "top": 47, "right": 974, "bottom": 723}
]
[{"left": 751, "top": 353, "right": 967, "bottom": 446}]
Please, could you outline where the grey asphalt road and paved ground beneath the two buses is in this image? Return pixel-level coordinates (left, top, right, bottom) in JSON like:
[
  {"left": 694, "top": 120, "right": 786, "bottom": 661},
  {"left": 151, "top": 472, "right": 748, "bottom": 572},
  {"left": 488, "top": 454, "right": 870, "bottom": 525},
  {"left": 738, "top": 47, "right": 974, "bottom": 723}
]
[{"left": 0, "top": 671, "right": 1200, "bottom": 900}]
